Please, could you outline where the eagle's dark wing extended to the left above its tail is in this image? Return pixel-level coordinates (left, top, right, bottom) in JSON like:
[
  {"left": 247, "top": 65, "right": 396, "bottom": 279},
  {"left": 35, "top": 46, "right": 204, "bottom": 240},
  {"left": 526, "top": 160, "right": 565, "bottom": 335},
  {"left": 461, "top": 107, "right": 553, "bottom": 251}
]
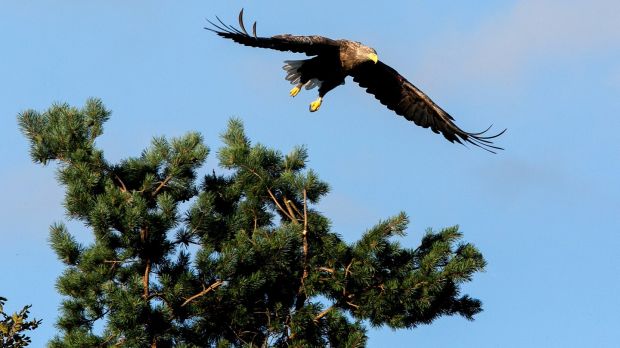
[{"left": 205, "top": 9, "right": 339, "bottom": 56}]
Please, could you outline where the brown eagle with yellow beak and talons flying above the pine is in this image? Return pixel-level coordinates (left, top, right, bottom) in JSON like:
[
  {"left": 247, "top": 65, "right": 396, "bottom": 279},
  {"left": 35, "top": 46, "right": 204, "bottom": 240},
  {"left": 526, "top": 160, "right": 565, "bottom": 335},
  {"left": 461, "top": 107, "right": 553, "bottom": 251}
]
[{"left": 205, "top": 9, "right": 506, "bottom": 153}]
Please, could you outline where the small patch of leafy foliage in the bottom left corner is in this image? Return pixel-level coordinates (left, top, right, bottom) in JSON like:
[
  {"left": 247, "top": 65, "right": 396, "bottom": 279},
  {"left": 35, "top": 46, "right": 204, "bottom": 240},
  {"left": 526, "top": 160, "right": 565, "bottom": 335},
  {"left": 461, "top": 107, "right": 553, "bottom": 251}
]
[{"left": 0, "top": 296, "right": 41, "bottom": 348}]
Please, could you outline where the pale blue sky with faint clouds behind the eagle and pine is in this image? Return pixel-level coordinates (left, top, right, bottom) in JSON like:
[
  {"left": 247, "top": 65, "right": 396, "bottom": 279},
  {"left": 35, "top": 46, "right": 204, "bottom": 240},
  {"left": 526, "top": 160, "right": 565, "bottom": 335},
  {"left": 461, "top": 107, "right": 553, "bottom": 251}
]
[{"left": 0, "top": 0, "right": 620, "bottom": 347}]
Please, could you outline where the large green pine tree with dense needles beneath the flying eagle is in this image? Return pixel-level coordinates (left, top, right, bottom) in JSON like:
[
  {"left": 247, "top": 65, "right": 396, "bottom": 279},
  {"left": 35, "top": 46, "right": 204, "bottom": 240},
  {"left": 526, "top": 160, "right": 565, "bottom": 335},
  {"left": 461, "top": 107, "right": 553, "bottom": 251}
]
[{"left": 18, "top": 99, "right": 485, "bottom": 347}]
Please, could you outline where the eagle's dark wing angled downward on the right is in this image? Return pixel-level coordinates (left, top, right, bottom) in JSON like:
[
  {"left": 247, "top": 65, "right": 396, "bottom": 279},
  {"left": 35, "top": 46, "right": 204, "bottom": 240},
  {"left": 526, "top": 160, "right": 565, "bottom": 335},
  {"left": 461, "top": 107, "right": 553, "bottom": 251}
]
[{"left": 351, "top": 61, "right": 506, "bottom": 153}]
